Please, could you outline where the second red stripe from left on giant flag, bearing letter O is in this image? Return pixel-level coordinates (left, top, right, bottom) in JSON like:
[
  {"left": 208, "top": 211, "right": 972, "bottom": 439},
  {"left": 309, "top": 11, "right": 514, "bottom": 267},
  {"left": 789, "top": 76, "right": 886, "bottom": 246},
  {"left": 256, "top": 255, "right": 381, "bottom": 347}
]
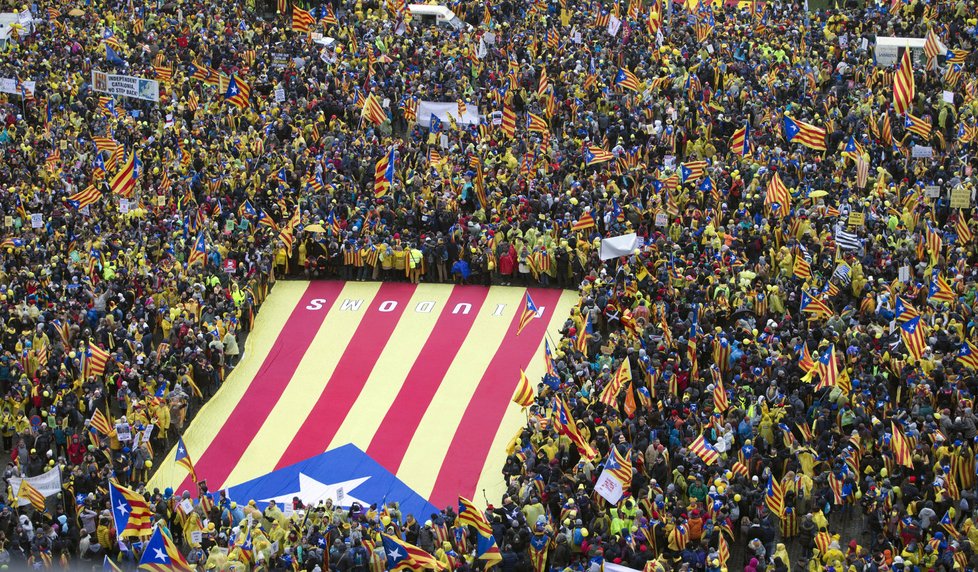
[{"left": 275, "top": 283, "right": 416, "bottom": 469}]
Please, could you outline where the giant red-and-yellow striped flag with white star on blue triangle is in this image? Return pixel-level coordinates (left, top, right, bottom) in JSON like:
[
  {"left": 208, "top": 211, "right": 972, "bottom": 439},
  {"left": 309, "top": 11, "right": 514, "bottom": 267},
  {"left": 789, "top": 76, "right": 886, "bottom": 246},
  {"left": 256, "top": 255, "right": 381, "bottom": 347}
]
[{"left": 151, "top": 281, "right": 577, "bottom": 514}]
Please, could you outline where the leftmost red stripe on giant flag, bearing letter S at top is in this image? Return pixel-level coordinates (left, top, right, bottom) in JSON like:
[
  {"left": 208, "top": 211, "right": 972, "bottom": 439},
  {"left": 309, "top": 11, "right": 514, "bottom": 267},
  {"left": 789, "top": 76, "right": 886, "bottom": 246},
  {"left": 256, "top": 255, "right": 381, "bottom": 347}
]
[{"left": 177, "top": 282, "right": 343, "bottom": 491}]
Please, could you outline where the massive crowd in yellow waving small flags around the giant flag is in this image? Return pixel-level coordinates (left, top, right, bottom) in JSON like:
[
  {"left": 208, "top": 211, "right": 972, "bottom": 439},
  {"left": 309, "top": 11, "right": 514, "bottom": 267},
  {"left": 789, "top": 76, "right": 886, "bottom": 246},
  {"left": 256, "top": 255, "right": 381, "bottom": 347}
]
[{"left": 0, "top": 0, "right": 978, "bottom": 572}]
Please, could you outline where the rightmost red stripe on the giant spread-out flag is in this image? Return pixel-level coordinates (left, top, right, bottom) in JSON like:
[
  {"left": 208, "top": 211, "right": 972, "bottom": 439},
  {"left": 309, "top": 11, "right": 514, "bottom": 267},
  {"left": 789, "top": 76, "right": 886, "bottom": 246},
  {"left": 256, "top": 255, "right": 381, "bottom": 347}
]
[{"left": 430, "top": 289, "right": 561, "bottom": 506}]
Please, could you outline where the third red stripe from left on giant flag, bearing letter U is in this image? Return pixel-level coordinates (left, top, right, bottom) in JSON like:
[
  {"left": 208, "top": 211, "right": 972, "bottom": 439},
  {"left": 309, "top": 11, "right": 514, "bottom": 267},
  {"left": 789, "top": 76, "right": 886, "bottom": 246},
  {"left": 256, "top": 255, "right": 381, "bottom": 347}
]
[{"left": 367, "top": 286, "right": 489, "bottom": 473}]
